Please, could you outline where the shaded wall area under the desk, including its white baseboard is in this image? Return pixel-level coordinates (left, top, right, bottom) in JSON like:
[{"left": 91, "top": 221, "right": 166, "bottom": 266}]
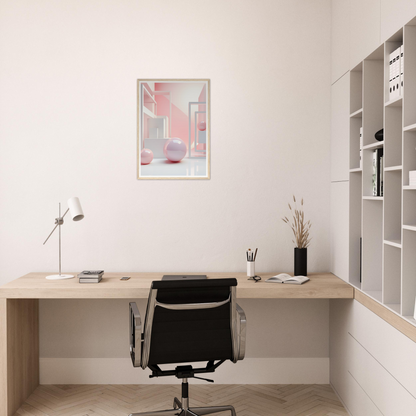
[{"left": 40, "top": 299, "right": 329, "bottom": 384}]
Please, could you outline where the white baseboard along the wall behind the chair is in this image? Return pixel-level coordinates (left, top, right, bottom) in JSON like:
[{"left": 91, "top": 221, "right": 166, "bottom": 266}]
[{"left": 40, "top": 358, "right": 329, "bottom": 384}]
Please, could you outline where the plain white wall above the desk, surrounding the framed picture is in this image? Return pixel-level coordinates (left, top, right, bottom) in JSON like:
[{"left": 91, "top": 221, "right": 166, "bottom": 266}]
[{"left": 0, "top": 0, "right": 330, "bottom": 382}]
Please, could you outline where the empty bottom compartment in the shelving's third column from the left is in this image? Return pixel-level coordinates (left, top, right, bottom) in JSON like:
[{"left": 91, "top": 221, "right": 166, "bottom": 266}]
[{"left": 383, "top": 244, "right": 402, "bottom": 306}]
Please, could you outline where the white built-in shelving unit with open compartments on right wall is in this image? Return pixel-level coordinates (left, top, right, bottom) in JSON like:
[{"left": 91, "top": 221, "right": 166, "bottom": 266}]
[{"left": 349, "top": 18, "right": 416, "bottom": 326}]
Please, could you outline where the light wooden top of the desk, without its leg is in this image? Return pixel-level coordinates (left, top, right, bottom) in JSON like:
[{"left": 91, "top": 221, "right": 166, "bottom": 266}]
[{"left": 0, "top": 272, "right": 354, "bottom": 299}]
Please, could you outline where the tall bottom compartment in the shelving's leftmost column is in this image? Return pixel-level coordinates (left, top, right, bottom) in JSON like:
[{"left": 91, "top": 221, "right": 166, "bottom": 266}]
[{"left": 349, "top": 171, "right": 362, "bottom": 288}]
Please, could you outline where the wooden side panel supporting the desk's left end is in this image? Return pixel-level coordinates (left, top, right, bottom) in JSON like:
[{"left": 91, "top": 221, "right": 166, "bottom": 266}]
[{"left": 0, "top": 299, "right": 39, "bottom": 416}]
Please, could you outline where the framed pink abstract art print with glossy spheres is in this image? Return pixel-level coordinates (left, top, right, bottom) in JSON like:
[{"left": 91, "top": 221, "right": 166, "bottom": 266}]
[{"left": 137, "top": 79, "right": 211, "bottom": 179}]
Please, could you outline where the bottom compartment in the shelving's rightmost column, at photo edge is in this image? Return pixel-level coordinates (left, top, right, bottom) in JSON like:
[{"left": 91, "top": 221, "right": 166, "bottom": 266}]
[{"left": 401, "top": 231, "right": 416, "bottom": 316}]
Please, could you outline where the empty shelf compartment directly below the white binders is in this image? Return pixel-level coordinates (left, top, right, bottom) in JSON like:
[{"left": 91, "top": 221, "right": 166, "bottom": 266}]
[{"left": 384, "top": 107, "right": 403, "bottom": 166}]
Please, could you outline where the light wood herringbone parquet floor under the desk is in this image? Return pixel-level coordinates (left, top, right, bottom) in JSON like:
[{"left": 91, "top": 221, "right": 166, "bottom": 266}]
[{"left": 15, "top": 384, "right": 348, "bottom": 416}]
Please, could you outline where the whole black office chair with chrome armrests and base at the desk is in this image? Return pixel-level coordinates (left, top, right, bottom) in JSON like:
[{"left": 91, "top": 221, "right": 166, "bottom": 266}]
[{"left": 130, "top": 279, "right": 246, "bottom": 416}]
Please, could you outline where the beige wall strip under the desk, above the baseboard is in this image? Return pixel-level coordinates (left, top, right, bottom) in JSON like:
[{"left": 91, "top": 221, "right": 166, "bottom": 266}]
[{"left": 40, "top": 299, "right": 329, "bottom": 358}]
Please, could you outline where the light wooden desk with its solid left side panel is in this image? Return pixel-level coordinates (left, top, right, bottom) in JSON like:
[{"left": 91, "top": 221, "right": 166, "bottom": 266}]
[{"left": 0, "top": 273, "right": 354, "bottom": 416}]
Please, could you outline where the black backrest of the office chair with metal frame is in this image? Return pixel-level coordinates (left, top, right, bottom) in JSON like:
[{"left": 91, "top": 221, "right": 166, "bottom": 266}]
[{"left": 141, "top": 279, "right": 238, "bottom": 368}]
